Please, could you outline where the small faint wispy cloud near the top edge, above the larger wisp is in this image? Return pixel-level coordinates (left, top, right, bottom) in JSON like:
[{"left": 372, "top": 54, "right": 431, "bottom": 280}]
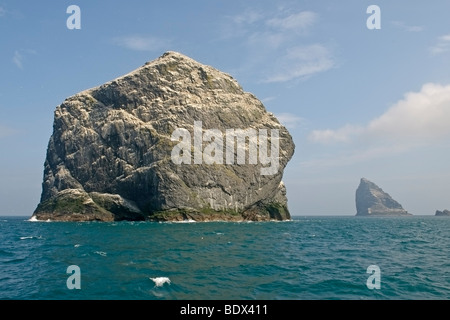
[{"left": 266, "top": 11, "right": 317, "bottom": 33}]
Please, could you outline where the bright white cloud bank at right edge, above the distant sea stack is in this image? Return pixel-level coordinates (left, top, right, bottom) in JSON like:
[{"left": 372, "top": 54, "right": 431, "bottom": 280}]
[{"left": 309, "top": 83, "right": 450, "bottom": 147}]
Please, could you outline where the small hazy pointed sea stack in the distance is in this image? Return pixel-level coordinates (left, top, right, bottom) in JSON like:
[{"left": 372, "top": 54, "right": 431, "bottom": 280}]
[{"left": 356, "top": 178, "right": 410, "bottom": 216}]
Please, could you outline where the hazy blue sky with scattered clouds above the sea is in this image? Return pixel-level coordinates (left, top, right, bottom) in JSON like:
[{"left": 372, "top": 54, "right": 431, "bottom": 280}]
[{"left": 0, "top": 0, "right": 450, "bottom": 216}]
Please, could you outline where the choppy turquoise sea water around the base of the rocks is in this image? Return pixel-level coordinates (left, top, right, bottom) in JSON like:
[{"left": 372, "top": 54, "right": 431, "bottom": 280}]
[{"left": 0, "top": 216, "right": 450, "bottom": 300}]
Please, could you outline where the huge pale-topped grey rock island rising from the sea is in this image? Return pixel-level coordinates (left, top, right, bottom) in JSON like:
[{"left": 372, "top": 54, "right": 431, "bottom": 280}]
[{"left": 33, "top": 52, "right": 295, "bottom": 221}]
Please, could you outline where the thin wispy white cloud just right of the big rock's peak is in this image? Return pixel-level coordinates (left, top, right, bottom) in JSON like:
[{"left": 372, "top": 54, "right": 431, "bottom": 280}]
[{"left": 264, "top": 44, "right": 335, "bottom": 83}]
